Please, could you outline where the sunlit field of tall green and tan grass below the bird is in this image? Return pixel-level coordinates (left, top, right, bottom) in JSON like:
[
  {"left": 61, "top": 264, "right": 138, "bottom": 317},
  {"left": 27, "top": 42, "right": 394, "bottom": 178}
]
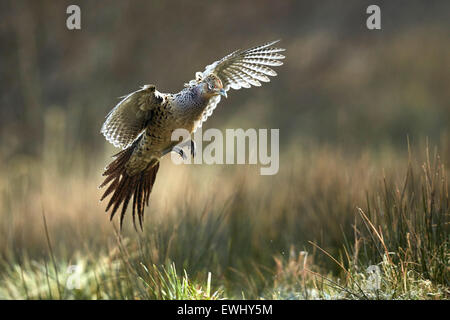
[{"left": 0, "top": 136, "right": 450, "bottom": 299}]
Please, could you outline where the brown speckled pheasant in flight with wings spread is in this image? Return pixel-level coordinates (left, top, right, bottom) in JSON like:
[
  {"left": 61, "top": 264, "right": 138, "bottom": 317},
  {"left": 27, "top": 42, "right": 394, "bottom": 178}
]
[{"left": 100, "top": 40, "right": 285, "bottom": 230}]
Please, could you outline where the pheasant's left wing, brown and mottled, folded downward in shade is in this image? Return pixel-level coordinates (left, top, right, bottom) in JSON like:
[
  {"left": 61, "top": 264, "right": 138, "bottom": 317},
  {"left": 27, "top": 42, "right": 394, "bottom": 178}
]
[{"left": 101, "top": 85, "right": 163, "bottom": 149}]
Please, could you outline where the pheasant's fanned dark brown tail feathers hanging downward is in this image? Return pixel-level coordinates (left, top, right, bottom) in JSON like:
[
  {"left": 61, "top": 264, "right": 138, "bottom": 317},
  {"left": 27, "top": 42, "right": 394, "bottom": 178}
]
[{"left": 99, "top": 146, "right": 159, "bottom": 230}]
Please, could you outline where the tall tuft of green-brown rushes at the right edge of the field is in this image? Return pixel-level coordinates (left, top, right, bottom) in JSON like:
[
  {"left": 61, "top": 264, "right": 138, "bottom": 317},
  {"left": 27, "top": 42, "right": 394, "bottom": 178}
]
[{"left": 353, "top": 149, "right": 450, "bottom": 287}]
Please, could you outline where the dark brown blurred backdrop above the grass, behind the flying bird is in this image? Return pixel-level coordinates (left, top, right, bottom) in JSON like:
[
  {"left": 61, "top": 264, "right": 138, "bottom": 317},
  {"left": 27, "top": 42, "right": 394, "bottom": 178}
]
[{"left": 0, "top": 0, "right": 450, "bottom": 159}]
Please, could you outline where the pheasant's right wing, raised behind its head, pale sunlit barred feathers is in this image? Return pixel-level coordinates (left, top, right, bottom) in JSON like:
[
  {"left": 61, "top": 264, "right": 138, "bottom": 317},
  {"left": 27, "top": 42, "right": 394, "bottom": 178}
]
[{"left": 202, "top": 40, "right": 285, "bottom": 91}]
